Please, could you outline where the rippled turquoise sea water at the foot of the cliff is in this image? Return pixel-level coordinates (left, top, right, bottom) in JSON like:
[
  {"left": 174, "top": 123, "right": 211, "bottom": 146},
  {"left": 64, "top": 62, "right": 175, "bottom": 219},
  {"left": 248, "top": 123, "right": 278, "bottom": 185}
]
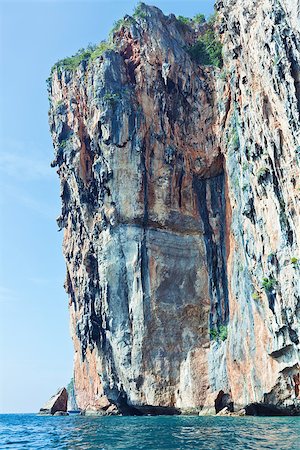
[{"left": 0, "top": 414, "right": 300, "bottom": 450}]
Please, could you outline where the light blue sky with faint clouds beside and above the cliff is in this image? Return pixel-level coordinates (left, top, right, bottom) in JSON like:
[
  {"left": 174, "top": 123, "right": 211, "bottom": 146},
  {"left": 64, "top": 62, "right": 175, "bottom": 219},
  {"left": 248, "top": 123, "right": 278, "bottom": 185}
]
[{"left": 0, "top": 0, "right": 213, "bottom": 413}]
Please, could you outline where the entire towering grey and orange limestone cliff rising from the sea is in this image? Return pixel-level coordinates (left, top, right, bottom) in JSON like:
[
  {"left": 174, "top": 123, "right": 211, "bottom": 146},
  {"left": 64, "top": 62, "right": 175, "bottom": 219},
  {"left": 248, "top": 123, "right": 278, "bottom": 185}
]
[{"left": 49, "top": 0, "right": 300, "bottom": 414}]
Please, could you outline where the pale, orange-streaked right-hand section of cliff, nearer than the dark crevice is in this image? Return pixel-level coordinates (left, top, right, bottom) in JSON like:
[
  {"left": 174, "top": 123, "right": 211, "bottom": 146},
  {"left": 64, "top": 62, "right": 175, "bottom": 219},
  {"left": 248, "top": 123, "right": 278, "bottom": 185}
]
[{"left": 213, "top": 0, "right": 300, "bottom": 410}]
